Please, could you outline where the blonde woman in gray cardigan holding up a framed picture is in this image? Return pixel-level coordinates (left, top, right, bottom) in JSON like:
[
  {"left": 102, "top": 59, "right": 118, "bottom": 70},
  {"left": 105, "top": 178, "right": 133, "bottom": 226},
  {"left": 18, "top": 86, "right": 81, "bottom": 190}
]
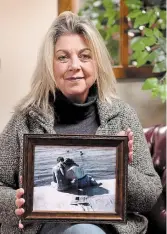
[{"left": 0, "top": 12, "right": 161, "bottom": 234}]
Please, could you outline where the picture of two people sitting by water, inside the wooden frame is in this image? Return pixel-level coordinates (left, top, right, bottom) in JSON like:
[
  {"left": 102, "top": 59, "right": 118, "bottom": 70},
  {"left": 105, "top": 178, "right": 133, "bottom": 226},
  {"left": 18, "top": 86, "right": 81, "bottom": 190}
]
[{"left": 33, "top": 146, "right": 116, "bottom": 213}]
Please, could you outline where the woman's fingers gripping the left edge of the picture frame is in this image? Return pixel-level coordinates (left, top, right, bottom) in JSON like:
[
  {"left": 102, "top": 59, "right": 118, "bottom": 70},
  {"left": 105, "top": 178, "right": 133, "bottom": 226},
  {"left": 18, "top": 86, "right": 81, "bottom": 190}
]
[{"left": 15, "top": 188, "right": 25, "bottom": 229}]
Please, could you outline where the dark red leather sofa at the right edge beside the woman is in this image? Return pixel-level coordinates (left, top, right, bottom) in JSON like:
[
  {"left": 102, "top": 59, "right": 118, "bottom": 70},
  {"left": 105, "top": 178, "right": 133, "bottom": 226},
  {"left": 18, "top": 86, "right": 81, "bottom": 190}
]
[{"left": 143, "top": 125, "right": 167, "bottom": 234}]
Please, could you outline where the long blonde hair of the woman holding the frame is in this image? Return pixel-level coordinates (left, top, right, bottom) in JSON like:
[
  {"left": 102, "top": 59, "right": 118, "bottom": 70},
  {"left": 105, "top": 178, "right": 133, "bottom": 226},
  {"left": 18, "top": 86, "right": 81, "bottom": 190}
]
[{"left": 16, "top": 11, "right": 117, "bottom": 113}]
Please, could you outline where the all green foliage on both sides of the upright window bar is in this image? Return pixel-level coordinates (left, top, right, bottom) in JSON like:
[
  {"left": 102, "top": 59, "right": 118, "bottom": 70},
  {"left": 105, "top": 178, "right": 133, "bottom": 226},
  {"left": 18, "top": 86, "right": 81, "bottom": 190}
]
[{"left": 79, "top": 0, "right": 167, "bottom": 102}]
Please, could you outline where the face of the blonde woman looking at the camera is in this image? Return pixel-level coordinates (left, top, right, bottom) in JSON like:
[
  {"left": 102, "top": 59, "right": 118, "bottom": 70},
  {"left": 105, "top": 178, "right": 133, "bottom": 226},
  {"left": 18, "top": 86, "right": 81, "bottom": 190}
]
[{"left": 53, "top": 34, "right": 96, "bottom": 103}]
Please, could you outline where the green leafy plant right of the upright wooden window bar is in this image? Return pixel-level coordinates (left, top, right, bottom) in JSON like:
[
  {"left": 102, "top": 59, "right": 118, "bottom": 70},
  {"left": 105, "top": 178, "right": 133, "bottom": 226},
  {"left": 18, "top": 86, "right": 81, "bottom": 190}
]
[{"left": 126, "top": 0, "right": 167, "bottom": 102}]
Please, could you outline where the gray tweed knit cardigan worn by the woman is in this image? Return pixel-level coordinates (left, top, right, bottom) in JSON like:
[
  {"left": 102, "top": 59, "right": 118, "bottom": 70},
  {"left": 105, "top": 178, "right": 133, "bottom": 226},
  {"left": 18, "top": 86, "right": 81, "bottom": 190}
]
[{"left": 0, "top": 99, "right": 161, "bottom": 234}]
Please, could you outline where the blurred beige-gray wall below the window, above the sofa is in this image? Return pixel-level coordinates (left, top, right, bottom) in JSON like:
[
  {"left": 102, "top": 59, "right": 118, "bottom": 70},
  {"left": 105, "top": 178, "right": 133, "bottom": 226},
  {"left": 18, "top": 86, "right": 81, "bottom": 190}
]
[{"left": 117, "top": 77, "right": 166, "bottom": 127}]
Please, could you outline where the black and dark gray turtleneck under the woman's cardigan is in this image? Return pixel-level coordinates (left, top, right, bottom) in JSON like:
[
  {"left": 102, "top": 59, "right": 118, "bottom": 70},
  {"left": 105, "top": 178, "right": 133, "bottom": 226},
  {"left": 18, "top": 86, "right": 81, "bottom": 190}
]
[{"left": 54, "top": 86, "right": 99, "bottom": 135}]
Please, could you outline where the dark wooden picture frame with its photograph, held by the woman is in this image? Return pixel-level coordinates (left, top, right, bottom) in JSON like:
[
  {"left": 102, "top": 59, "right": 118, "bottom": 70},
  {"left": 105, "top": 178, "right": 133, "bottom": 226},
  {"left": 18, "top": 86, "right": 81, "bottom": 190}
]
[{"left": 23, "top": 134, "right": 128, "bottom": 223}]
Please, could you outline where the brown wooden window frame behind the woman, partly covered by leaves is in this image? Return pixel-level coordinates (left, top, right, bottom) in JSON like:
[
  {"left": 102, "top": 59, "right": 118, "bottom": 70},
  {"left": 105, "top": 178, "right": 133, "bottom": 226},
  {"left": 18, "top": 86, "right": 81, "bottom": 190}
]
[{"left": 58, "top": 0, "right": 161, "bottom": 78}]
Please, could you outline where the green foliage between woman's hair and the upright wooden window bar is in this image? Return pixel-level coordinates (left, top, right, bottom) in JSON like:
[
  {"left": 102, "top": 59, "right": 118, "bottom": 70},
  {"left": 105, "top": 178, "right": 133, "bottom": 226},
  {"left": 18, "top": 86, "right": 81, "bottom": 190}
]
[{"left": 79, "top": 0, "right": 119, "bottom": 64}]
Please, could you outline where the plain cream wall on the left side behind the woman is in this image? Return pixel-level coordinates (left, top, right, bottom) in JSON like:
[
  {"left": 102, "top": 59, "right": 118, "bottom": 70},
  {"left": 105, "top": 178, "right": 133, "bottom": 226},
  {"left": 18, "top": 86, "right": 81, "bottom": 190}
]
[{"left": 0, "top": 0, "right": 58, "bottom": 132}]
